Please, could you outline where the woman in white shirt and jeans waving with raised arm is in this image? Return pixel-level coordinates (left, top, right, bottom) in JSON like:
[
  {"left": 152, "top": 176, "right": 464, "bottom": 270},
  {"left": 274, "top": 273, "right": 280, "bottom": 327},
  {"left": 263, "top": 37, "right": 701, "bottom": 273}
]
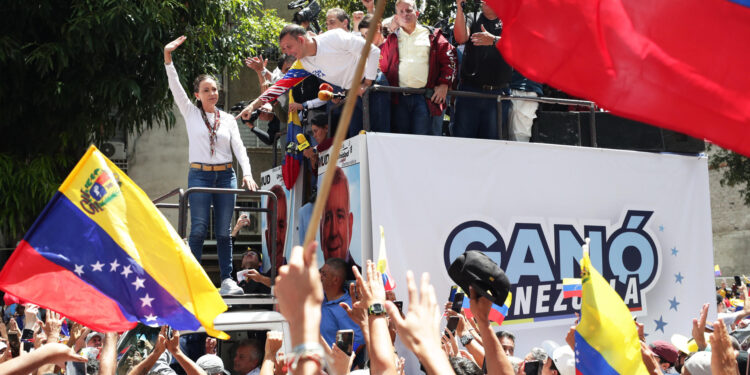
[{"left": 164, "top": 36, "right": 258, "bottom": 295}]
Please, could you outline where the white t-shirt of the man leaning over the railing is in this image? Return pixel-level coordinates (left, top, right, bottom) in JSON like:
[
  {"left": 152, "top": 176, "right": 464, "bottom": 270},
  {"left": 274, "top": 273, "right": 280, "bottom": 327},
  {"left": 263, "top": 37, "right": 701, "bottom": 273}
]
[{"left": 300, "top": 29, "right": 380, "bottom": 89}]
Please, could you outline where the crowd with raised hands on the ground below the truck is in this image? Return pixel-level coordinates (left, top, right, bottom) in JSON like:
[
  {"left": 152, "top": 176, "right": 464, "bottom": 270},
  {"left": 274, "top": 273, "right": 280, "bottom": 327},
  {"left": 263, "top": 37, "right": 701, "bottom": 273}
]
[{"left": 0, "top": 247, "right": 750, "bottom": 375}]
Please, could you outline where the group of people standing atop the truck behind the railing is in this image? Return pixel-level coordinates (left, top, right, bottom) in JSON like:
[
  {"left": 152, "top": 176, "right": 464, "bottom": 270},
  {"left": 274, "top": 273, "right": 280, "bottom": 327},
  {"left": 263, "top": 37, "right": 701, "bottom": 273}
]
[{"left": 241, "top": 0, "right": 542, "bottom": 142}]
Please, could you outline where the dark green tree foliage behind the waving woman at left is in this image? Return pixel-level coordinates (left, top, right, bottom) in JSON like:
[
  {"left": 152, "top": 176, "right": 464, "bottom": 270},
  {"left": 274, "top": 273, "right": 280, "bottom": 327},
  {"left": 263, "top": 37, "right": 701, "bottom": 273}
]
[{"left": 0, "top": 0, "right": 284, "bottom": 245}]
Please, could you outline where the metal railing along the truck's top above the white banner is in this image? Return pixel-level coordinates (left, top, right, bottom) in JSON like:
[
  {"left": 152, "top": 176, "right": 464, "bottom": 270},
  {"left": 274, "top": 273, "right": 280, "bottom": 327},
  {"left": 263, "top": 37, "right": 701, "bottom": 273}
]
[{"left": 362, "top": 85, "right": 597, "bottom": 147}]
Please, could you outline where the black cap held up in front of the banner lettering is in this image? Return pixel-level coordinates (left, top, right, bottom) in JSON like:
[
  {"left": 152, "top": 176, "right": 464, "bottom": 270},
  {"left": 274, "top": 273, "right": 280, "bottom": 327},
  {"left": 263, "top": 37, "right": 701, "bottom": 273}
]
[{"left": 448, "top": 250, "right": 510, "bottom": 305}]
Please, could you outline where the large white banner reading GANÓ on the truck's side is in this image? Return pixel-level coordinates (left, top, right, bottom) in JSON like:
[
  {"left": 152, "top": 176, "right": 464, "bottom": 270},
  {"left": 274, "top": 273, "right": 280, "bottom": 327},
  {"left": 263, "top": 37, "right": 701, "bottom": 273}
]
[{"left": 366, "top": 134, "right": 716, "bottom": 356}]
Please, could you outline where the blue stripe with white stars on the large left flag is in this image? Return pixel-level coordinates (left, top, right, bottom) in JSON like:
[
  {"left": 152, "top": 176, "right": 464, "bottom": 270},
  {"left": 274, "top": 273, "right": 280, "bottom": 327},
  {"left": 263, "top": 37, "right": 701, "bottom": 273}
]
[{"left": 25, "top": 192, "right": 200, "bottom": 330}]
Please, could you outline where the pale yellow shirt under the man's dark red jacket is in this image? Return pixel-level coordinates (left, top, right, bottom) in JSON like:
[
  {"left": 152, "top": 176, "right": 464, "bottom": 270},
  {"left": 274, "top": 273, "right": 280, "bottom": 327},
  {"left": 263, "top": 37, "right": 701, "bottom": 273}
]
[{"left": 398, "top": 25, "right": 430, "bottom": 88}]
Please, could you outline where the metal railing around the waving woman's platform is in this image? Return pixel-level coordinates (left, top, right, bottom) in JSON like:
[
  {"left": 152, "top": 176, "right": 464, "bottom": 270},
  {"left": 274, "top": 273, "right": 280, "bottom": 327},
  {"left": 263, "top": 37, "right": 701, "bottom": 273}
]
[{"left": 152, "top": 187, "right": 283, "bottom": 284}]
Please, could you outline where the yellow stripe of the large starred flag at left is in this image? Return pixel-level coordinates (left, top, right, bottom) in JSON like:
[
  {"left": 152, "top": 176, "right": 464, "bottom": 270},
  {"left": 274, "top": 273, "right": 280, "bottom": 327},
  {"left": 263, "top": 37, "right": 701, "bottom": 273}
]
[{"left": 59, "top": 146, "right": 229, "bottom": 339}]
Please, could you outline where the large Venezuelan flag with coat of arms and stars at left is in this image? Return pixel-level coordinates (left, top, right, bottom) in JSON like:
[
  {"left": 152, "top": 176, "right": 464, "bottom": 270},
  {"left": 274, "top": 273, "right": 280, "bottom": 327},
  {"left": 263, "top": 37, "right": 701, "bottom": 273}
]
[{"left": 0, "top": 146, "right": 229, "bottom": 338}]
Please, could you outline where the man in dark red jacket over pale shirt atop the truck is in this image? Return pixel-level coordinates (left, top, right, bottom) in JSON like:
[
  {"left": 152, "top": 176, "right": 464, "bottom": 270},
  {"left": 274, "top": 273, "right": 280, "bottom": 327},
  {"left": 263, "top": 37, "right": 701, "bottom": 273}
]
[{"left": 380, "top": 0, "right": 456, "bottom": 135}]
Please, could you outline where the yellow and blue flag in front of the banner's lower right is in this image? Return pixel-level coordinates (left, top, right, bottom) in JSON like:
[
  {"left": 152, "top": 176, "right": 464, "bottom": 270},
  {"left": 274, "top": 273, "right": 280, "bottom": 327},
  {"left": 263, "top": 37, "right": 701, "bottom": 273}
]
[{"left": 575, "top": 251, "right": 648, "bottom": 375}]
